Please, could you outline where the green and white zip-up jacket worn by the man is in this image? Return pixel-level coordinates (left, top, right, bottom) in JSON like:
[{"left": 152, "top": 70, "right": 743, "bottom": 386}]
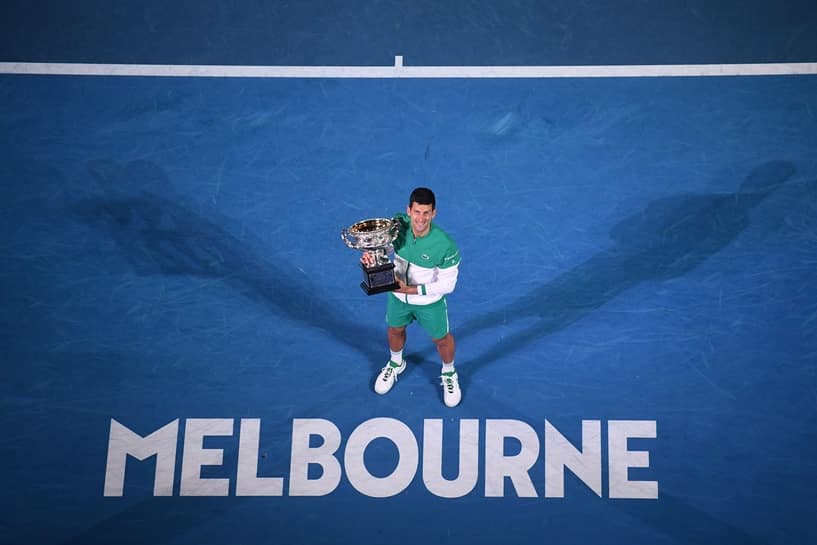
[{"left": 392, "top": 213, "right": 460, "bottom": 305}]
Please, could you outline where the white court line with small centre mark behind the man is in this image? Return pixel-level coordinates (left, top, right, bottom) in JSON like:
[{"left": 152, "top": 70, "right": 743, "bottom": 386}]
[{"left": 0, "top": 56, "right": 817, "bottom": 78}]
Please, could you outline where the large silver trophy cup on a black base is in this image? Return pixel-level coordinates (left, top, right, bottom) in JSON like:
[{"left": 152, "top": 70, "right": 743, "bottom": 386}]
[{"left": 340, "top": 218, "right": 400, "bottom": 295}]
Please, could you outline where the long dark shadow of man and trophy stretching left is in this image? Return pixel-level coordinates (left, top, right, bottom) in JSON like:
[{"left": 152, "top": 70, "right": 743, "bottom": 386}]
[{"left": 73, "top": 157, "right": 383, "bottom": 360}]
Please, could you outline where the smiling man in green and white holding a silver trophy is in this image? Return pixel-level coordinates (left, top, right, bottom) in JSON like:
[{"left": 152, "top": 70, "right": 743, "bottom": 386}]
[{"left": 342, "top": 187, "right": 462, "bottom": 407}]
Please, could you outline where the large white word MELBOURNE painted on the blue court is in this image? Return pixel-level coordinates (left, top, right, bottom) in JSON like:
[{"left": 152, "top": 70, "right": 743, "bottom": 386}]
[{"left": 104, "top": 418, "right": 658, "bottom": 499}]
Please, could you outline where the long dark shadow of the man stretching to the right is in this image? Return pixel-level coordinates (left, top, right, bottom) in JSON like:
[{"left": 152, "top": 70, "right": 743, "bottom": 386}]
[{"left": 444, "top": 161, "right": 794, "bottom": 375}]
